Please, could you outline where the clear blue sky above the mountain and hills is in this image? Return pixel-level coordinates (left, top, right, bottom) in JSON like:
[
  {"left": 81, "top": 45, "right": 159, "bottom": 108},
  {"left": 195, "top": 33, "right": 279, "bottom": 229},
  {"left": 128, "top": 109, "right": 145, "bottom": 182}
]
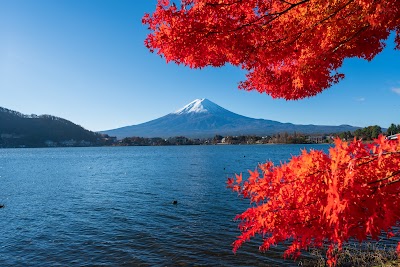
[{"left": 0, "top": 0, "right": 400, "bottom": 131}]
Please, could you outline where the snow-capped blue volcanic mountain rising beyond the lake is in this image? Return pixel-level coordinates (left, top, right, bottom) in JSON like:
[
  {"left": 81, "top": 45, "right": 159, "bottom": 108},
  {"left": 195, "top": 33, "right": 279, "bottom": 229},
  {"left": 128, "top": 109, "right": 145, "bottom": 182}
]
[{"left": 102, "top": 98, "right": 359, "bottom": 139}]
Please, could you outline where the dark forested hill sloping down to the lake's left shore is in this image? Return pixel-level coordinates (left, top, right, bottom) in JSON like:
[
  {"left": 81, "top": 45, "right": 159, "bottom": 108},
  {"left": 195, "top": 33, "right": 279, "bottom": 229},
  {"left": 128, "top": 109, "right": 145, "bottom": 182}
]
[{"left": 0, "top": 107, "right": 111, "bottom": 147}]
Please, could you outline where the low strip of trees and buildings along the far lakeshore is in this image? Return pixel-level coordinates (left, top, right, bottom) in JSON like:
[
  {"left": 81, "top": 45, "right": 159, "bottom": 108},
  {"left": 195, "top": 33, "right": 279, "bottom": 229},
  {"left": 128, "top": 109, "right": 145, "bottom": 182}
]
[{"left": 0, "top": 124, "right": 400, "bottom": 148}]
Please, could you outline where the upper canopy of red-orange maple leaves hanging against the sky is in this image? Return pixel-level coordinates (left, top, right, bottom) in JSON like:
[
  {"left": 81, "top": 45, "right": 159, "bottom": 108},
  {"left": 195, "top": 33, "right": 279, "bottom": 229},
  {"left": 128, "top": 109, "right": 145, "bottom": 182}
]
[{"left": 143, "top": 0, "right": 400, "bottom": 99}]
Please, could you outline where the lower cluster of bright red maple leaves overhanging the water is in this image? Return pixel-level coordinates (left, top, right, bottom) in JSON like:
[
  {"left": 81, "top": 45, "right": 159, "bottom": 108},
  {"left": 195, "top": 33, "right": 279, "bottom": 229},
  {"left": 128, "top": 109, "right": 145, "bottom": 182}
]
[{"left": 228, "top": 136, "right": 400, "bottom": 266}]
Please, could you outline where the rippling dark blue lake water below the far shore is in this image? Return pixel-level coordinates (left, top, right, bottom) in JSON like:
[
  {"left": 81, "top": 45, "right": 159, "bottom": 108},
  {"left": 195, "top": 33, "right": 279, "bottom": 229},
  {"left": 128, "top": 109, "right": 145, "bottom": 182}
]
[{"left": 0, "top": 145, "right": 396, "bottom": 266}]
